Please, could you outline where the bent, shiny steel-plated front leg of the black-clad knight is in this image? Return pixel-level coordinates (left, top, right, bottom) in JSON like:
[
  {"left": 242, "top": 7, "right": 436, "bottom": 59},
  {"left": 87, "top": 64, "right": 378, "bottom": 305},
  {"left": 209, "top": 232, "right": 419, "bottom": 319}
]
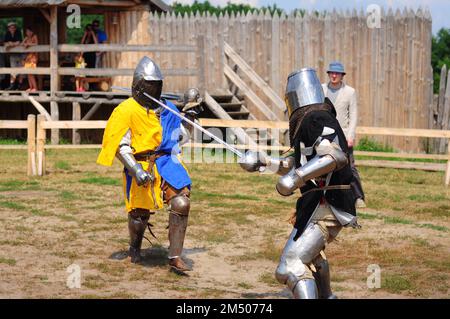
[{"left": 275, "top": 223, "right": 326, "bottom": 299}]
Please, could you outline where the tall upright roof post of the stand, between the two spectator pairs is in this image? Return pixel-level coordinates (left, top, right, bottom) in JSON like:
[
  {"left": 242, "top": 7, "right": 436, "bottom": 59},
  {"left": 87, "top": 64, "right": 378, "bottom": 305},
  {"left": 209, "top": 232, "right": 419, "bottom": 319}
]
[{"left": 50, "top": 6, "right": 59, "bottom": 144}]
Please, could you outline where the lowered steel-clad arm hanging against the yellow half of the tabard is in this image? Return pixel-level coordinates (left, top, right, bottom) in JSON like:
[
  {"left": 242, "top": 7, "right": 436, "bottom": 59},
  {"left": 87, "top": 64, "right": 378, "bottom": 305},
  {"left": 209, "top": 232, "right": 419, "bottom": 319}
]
[{"left": 116, "top": 130, "right": 151, "bottom": 186}]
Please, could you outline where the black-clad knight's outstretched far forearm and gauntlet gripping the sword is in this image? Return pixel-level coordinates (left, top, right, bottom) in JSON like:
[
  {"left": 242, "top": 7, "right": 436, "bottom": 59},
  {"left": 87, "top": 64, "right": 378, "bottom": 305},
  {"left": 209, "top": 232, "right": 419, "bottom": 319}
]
[{"left": 239, "top": 151, "right": 294, "bottom": 175}]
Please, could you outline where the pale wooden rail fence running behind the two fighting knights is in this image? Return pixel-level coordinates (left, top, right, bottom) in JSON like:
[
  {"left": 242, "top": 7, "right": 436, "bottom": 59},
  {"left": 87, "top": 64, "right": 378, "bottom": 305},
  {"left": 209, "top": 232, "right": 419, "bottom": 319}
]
[{"left": 33, "top": 115, "right": 450, "bottom": 186}]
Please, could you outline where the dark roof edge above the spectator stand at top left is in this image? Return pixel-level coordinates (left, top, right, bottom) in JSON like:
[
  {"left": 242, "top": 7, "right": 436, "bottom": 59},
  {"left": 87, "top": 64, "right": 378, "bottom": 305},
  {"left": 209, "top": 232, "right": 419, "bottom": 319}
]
[{"left": 0, "top": 0, "right": 171, "bottom": 11}]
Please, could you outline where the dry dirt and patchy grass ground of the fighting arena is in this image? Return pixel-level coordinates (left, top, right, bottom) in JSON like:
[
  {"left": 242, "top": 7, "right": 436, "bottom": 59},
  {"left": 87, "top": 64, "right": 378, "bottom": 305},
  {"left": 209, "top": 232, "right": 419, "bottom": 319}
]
[{"left": 0, "top": 150, "right": 450, "bottom": 298}]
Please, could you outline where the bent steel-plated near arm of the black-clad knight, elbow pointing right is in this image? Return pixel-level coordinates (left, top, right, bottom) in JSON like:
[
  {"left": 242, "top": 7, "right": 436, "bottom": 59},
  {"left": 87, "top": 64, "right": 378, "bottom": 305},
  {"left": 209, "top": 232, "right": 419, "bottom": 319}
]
[{"left": 276, "top": 139, "right": 348, "bottom": 196}]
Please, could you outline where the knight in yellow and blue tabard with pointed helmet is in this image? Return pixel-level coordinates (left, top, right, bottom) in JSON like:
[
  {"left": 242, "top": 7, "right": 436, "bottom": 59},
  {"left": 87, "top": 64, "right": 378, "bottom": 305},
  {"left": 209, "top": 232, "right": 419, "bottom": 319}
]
[{"left": 97, "top": 57, "right": 196, "bottom": 272}]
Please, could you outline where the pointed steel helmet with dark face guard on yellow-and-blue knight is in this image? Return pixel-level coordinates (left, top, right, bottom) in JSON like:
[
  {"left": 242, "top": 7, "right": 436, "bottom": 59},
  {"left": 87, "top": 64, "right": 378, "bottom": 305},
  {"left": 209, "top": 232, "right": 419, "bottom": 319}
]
[{"left": 131, "top": 56, "right": 164, "bottom": 109}]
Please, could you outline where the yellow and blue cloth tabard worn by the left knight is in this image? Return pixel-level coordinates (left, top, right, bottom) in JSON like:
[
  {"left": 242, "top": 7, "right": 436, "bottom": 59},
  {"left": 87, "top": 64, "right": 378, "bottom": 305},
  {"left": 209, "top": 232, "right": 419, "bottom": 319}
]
[{"left": 97, "top": 98, "right": 191, "bottom": 212}]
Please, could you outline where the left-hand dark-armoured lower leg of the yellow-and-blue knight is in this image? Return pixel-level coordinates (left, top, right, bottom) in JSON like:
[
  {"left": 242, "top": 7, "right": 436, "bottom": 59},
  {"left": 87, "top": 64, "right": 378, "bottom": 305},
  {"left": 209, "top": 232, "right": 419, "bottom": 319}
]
[{"left": 128, "top": 209, "right": 150, "bottom": 264}]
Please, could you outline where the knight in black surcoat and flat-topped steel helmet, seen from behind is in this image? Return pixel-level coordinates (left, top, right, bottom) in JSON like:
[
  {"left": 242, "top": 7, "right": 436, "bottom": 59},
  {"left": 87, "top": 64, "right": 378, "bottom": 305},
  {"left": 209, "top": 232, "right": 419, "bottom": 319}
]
[{"left": 240, "top": 68, "right": 359, "bottom": 299}]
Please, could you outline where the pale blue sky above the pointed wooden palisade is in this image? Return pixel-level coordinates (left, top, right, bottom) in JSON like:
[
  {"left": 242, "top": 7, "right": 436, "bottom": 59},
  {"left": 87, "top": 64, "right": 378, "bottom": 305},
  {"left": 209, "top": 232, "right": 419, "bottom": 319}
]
[{"left": 166, "top": 0, "right": 450, "bottom": 34}]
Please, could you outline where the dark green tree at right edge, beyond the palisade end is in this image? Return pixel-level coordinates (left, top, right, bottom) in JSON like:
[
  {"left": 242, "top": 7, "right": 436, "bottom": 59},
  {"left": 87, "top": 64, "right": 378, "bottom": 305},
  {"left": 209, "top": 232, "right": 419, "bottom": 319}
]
[{"left": 431, "top": 28, "right": 450, "bottom": 93}]
